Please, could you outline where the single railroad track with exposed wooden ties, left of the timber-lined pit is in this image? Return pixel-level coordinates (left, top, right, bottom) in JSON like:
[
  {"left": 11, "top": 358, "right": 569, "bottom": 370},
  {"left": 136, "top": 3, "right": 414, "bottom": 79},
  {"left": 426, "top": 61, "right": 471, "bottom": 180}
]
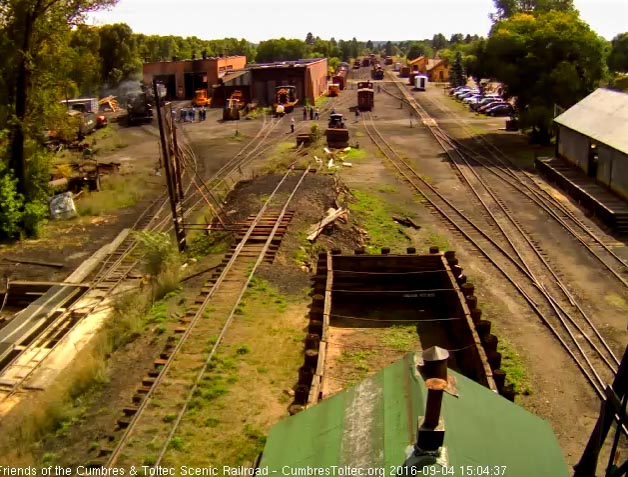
[{"left": 95, "top": 167, "right": 310, "bottom": 468}]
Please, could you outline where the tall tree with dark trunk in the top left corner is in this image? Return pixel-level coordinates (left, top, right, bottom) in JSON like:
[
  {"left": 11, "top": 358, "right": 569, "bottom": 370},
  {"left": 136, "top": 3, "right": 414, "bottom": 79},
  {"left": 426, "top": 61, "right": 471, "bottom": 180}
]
[{"left": 2, "top": 0, "right": 116, "bottom": 199}]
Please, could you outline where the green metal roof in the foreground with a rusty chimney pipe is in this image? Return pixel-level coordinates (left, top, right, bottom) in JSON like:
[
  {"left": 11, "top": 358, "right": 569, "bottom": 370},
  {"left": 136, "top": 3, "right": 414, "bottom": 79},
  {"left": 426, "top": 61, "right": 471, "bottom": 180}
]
[{"left": 259, "top": 353, "right": 569, "bottom": 477}]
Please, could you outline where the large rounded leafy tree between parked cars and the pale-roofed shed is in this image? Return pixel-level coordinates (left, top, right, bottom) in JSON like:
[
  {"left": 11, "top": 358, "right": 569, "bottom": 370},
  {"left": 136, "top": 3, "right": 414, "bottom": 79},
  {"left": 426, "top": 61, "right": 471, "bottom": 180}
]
[{"left": 485, "top": 11, "right": 604, "bottom": 142}]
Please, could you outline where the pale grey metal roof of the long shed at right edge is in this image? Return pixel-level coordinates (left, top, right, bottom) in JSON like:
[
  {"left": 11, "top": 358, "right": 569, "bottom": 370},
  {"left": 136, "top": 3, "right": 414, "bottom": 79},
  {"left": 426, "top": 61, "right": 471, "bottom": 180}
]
[{"left": 554, "top": 88, "right": 628, "bottom": 154}]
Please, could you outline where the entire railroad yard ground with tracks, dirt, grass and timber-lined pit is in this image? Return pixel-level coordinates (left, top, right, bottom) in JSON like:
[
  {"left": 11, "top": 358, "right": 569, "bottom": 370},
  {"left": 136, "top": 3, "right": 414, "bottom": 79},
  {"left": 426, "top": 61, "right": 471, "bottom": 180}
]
[{"left": 0, "top": 60, "right": 628, "bottom": 467}]
